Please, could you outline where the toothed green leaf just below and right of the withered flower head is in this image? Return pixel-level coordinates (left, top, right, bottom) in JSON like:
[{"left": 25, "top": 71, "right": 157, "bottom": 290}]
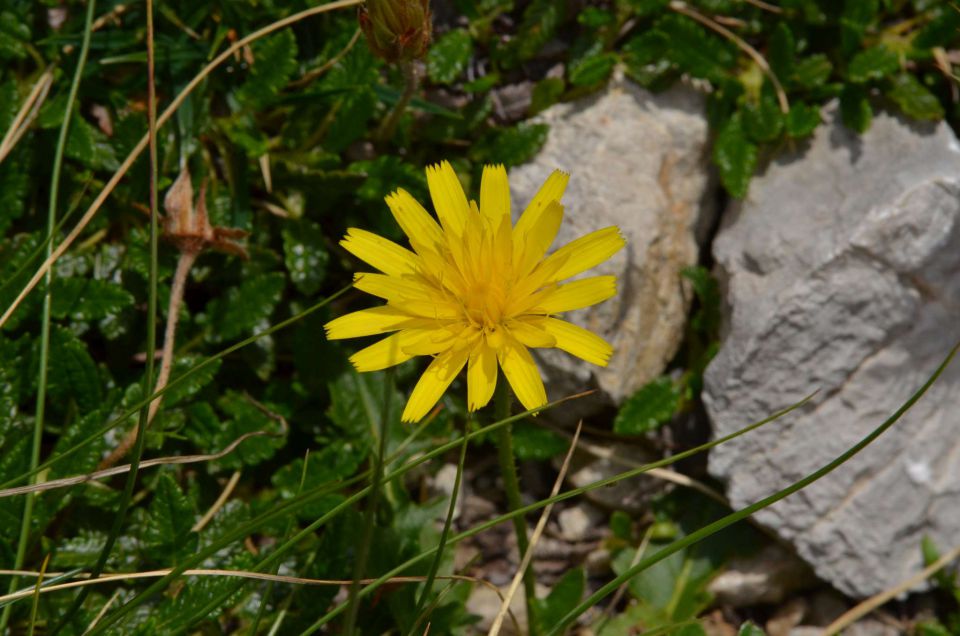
[{"left": 207, "top": 272, "right": 286, "bottom": 342}]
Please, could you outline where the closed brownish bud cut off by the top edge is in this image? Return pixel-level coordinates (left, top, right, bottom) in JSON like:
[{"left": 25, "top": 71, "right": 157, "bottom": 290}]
[{"left": 359, "top": 0, "right": 433, "bottom": 63}]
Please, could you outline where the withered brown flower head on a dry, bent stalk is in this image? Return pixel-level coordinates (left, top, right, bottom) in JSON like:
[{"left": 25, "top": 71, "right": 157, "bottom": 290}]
[{"left": 163, "top": 168, "right": 248, "bottom": 258}]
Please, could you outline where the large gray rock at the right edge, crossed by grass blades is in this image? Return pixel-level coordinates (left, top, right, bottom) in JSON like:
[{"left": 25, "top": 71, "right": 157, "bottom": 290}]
[{"left": 704, "top": 102, "right": 960, "bottom": 597}]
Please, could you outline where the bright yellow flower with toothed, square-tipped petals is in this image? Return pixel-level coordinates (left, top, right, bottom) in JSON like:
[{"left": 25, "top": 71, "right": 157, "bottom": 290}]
[{"left": 325, "top": 162, "right": 625, "bottom": 422}]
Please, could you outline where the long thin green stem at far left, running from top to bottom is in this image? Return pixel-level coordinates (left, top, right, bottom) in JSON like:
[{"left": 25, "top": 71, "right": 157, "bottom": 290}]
[{"left": 0, "top": 0, "right": 96, "bottom": 633}]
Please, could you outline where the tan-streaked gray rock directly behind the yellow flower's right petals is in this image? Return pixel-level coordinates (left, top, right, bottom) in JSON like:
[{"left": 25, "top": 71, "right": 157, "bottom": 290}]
[{"left": 510, "top": 74, "right": 715, "bottom": 410}]
